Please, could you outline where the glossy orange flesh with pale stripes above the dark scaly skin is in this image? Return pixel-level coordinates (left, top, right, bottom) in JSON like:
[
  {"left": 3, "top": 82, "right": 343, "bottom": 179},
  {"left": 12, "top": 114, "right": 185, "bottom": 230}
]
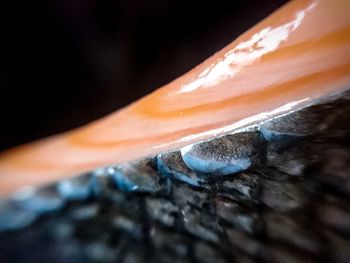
[{"left": 0, "top": 0, "right": 350, "bottom": 195}]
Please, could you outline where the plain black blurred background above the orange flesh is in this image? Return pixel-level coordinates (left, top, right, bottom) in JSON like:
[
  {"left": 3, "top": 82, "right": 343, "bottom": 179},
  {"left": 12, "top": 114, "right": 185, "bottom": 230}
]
[{"left": 0, "top": 0, "right": 287, "bottom": 150}]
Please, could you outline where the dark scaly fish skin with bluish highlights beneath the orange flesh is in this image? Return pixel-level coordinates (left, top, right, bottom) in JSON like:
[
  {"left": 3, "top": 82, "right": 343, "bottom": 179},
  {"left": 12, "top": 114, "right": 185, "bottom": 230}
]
[{"left": 0, "top": 91, "right": 350, "bottom": 262}]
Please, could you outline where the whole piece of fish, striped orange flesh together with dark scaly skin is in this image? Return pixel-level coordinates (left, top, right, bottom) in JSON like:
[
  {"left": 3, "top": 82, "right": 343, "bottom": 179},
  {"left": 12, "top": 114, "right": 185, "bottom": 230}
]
[{"left": 0, "top": 0, "right": 350, "bottom": 263}]
